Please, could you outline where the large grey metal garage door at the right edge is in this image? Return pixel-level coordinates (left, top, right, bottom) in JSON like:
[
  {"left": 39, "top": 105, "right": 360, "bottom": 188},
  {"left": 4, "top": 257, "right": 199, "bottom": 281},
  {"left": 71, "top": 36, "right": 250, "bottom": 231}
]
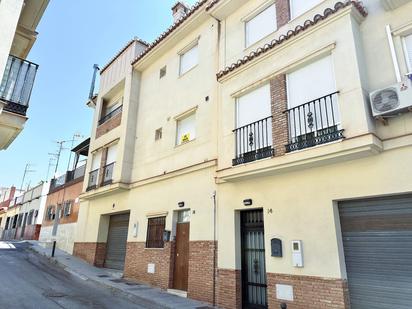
[{"left": 339, "top": 195, "right": 412, "bottom": 309}]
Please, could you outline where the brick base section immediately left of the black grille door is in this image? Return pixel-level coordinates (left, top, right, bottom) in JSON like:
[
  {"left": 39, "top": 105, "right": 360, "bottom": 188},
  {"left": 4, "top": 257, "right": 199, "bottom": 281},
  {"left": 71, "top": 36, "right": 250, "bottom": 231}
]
[{"left": 217, "top": 268, "right": 242, "bottom": 309}]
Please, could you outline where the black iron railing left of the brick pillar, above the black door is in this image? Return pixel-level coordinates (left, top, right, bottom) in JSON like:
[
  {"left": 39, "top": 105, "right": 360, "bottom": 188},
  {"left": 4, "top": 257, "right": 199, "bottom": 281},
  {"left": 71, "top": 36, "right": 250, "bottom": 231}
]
[{"left": 232, "top": 116, "right": 274, "bottom": 165}]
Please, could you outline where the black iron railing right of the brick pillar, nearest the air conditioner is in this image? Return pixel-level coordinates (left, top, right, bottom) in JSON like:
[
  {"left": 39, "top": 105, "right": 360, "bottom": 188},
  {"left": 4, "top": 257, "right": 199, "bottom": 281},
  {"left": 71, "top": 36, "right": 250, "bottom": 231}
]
[{"left": 285, "top": 91, "right": 344, "bottom": 152}]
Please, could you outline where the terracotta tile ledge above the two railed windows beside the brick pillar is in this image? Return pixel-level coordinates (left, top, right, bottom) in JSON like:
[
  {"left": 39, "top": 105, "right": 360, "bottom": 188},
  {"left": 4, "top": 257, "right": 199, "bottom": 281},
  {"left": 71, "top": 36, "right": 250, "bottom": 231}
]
[{"left": 215, "top": 0, "right": 368, "bottom": 80}]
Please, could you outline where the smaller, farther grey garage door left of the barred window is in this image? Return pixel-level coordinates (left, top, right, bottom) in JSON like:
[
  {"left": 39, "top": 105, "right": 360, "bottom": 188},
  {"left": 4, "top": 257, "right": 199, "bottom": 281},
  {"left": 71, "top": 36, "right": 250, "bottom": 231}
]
[{"left": 104, "top": 214, "right": 129, "bottom": 270}]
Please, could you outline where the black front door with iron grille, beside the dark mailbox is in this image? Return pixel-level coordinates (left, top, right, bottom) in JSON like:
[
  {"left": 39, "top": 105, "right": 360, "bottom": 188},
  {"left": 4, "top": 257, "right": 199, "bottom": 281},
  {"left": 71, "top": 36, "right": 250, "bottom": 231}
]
[{"left": 240, "top": 210, "right": 267, "bottom": 309}]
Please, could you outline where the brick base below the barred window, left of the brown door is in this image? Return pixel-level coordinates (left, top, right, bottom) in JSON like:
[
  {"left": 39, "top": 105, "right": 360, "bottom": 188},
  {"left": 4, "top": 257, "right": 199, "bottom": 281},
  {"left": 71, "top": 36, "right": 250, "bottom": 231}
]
[{"left": 124, "top": 242, "right": 173, "bottom": 289}]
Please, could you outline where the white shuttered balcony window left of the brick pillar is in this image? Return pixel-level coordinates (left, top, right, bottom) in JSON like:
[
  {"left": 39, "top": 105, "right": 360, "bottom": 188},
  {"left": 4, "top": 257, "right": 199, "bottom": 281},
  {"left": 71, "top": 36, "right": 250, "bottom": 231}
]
[{"left": 235, "top": 84, "right": 273, "bottom": 154}]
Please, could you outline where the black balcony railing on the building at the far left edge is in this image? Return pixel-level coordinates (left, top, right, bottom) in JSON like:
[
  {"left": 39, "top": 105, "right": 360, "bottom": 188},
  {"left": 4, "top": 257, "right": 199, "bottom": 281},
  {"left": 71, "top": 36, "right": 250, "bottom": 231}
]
[{"left": 0, "top": 55, "right": 38, "bottom": 115}]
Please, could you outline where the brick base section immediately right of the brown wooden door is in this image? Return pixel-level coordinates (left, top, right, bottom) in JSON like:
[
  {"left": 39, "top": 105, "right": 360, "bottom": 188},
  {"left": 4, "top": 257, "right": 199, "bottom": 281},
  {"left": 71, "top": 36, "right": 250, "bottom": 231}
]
[{"left": 187, "top": 241, "right": 217, "bottom": 303}]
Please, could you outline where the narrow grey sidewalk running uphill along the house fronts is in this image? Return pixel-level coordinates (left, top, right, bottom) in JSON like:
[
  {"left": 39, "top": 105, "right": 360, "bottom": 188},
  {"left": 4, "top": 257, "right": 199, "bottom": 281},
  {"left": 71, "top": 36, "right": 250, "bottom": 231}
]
[{"left": 27, "top": 241, "right": 213, "bottom": 309}]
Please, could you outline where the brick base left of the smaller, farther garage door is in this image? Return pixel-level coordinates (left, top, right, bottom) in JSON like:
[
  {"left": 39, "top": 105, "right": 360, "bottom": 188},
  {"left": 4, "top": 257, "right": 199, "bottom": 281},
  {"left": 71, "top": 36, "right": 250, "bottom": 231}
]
[{"left": 73, "top": 242, "right": 106, "bottom": 267}]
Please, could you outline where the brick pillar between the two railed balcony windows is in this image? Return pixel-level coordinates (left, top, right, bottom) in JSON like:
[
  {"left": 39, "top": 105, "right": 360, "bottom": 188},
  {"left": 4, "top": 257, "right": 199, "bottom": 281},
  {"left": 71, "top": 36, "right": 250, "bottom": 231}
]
[{"left": 270, "top": 74, "right": 288, "bottom": 156}]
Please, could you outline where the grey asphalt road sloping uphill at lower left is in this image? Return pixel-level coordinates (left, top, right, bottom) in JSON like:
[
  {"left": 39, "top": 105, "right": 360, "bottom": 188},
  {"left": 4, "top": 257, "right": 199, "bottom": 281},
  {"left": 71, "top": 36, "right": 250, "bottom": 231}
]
[{"left": 0, "top": 241, "right": 148, "bottom": 309}]
